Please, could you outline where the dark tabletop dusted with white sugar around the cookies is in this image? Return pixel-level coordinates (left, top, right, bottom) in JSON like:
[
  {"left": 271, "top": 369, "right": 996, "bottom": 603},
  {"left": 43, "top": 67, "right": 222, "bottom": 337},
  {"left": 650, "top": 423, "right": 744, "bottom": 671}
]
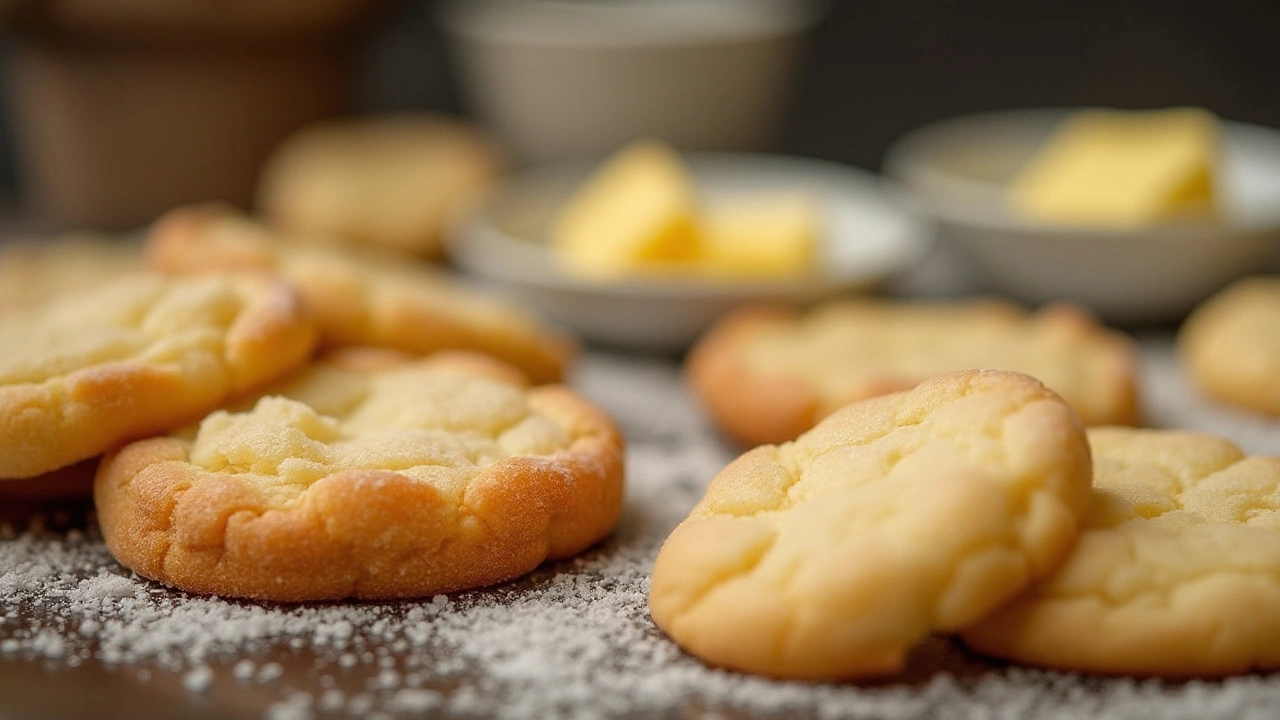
[{"left": 0, "top": 334, "right": 1280, "bottom": 720}]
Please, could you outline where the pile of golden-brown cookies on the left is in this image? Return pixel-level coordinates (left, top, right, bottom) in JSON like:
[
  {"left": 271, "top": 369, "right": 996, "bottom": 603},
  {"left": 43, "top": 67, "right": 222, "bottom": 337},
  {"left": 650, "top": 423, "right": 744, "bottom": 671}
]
[{"left": 0, "top": 205, "right": 622, "bottom": 601}]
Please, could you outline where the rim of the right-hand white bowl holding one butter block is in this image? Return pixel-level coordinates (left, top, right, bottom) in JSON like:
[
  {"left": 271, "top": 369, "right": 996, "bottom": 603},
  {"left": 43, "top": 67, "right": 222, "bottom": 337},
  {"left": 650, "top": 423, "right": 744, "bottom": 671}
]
[{"left": 881, "top": 105, "right": 1280, "bottom": 237}]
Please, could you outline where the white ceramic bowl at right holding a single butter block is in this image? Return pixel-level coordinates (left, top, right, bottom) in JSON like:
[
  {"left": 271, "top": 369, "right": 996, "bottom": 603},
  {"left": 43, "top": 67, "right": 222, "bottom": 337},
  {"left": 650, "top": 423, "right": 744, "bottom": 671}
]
[{"left": 884, "top": 109, "right": 1280, "bottom": 323}]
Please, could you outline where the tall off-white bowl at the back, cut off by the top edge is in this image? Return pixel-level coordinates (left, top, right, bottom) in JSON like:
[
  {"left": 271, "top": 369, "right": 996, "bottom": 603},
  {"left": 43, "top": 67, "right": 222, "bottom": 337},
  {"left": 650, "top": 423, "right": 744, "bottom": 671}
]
[{"left": 439, "top": 0, "right": 822, "bottom": 163}]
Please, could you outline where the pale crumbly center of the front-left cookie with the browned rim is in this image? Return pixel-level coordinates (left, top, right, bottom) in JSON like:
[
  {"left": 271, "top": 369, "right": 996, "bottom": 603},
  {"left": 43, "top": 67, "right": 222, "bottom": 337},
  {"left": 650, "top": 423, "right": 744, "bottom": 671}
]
[{"left": 191, "top": 372, "right": 571, "bottom": 496}]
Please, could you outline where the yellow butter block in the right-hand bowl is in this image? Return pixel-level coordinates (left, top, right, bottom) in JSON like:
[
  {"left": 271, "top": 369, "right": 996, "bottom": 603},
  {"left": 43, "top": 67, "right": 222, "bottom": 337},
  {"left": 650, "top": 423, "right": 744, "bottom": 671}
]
[{"left": 1010, "top": 109, "right": 1219, "bottom": 228}]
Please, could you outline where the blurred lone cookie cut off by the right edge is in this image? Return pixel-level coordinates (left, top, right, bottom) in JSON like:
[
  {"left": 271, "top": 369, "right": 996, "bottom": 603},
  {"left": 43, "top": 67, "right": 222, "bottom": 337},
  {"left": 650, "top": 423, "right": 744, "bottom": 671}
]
[{"left": 1178, "top": 275, "right": 1280, "bottom": 415}]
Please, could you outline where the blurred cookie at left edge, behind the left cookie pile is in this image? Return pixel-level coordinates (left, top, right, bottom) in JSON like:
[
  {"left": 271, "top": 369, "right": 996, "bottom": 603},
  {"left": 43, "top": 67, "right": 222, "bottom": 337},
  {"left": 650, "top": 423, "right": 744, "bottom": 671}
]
[{"left": 0, "top": 234, "right": 142, "bottom": 313}]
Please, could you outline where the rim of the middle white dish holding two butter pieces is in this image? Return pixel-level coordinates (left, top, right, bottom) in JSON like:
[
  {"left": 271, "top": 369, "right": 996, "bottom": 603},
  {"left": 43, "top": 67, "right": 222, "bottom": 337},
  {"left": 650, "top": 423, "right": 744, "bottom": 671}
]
[{"left": 445, "top": 152, "right": 933, "bottom": 301}]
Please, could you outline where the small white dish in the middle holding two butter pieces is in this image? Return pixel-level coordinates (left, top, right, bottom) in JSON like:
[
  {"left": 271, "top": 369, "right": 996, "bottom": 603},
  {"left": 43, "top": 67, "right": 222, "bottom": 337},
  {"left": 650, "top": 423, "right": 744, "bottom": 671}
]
[{"left": 449, "top": 154, "right": 929, "bottom": 351}]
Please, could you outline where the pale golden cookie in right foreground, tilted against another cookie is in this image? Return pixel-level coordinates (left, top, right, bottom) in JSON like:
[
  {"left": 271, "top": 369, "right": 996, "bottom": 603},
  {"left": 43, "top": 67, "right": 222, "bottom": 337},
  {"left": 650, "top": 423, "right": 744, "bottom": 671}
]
[{"left": 649, "top": 370, "right": 1089, "bottom": 679}]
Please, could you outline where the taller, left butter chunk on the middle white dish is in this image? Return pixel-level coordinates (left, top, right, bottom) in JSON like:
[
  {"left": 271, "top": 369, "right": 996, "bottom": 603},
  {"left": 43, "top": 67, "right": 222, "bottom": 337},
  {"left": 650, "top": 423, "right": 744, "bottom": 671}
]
[{"left": 549, "top": 142, "right": 698, "bottom": 279}]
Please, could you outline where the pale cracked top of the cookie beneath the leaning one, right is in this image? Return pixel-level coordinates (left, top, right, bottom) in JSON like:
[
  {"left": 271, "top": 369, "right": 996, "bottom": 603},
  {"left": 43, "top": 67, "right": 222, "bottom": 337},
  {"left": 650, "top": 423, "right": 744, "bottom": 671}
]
[{"left": 1038, "top": 428, "right": 1280, "bottom": 610}]
